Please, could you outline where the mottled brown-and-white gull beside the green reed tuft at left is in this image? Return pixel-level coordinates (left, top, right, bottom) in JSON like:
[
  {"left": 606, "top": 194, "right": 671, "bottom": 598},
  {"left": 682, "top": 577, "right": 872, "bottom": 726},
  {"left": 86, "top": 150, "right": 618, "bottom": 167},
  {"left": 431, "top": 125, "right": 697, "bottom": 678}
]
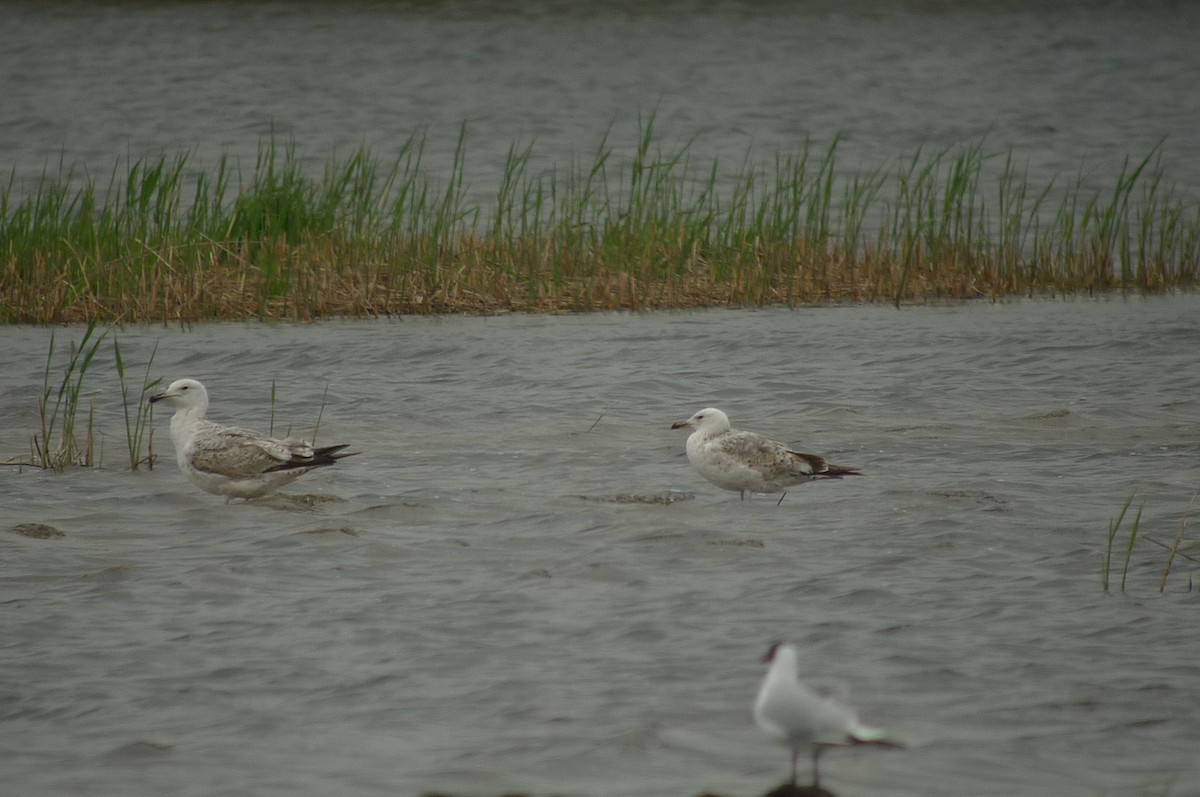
[{"left": 150, "top": 379, "right": 354, "bottom": 499}]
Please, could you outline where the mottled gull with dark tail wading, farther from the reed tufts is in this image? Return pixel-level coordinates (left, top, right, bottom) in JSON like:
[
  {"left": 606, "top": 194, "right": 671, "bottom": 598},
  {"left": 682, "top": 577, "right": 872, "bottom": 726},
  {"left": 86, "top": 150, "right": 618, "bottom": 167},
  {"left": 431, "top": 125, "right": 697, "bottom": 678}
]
[{"left": 671, "top": 407, "right": 862, "bottom": 502}]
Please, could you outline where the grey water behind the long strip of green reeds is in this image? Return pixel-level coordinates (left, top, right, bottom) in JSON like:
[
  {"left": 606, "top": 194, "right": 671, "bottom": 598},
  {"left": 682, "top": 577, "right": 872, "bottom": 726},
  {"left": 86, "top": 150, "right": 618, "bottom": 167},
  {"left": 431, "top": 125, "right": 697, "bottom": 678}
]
[{"left": 0, "top": 0, "right": 1200, "bottom": 206}]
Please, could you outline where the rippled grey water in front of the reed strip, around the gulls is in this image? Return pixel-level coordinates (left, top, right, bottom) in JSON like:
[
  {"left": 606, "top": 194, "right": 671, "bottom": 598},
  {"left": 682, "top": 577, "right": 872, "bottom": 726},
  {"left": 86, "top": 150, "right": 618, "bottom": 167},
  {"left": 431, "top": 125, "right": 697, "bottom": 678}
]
[{"left": 0, "top": 296, "right": 1200, "bottom": 797}]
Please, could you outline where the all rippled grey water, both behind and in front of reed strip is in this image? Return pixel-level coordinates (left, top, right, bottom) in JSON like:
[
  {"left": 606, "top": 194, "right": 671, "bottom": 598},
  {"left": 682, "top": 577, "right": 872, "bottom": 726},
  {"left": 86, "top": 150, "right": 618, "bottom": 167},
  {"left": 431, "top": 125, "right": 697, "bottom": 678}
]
[{"left": 0, "top": 1, "right": 1200, "bottom": 797}]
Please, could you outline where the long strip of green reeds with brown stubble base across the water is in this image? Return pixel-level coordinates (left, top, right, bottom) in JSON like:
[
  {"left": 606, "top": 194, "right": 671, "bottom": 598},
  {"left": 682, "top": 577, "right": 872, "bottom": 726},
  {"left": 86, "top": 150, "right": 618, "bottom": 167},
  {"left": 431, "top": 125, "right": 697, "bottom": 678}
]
[{"left": 0, "top": 122, "right": 1200, "bottom": 323}]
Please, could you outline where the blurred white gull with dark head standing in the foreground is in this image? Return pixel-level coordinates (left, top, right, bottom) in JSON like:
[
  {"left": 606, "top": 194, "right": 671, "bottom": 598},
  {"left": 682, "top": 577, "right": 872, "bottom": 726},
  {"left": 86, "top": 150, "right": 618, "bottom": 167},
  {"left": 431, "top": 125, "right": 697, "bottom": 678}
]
[{"left": 754, "top": 642, "right": 904, "bottom": 789}]
